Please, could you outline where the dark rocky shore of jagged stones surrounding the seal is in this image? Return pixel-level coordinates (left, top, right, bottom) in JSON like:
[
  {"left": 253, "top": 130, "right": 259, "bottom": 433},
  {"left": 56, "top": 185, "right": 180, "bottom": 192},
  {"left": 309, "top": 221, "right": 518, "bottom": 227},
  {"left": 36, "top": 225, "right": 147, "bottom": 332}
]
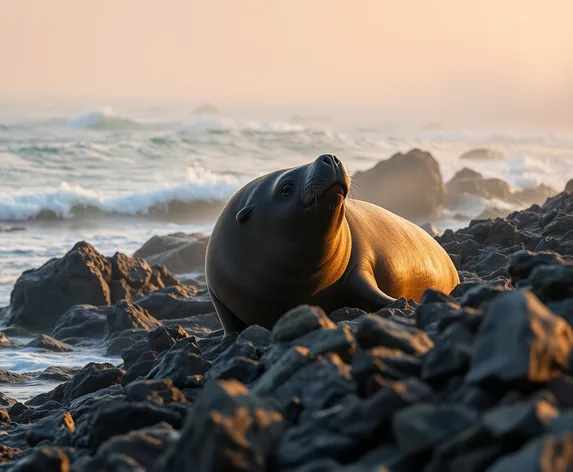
[{"left": 0, "top": 176, "right": 573, "bottom": 472}]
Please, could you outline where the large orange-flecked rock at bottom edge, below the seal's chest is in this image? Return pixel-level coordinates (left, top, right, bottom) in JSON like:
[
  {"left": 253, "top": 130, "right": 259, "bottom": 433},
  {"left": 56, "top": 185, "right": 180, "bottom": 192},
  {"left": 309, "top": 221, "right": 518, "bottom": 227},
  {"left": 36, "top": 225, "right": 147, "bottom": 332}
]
[{"left": 157, "top": 380, "right": 285, "bottom": 472}]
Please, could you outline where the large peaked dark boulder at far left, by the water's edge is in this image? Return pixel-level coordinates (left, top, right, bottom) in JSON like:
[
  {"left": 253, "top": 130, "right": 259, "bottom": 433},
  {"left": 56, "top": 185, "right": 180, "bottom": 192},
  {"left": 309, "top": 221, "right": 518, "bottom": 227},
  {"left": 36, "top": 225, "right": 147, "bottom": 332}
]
[{"left": 9, "top": 242, "right": 111, "bottom": 330}]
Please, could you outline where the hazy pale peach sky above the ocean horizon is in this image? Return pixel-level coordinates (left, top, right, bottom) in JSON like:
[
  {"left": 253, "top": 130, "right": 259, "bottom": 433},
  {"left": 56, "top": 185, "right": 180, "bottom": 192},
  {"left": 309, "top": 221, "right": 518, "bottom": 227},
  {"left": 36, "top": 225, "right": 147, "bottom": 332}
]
[{"left": 0, "top": 0, "right": 573, "bottom": 112}]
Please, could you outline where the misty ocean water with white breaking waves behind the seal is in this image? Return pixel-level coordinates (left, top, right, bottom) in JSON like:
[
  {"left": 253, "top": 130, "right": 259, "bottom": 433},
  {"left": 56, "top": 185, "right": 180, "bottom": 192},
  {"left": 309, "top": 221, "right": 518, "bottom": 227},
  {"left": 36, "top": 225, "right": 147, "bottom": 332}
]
[{"left": 0, "top": 104, "right": 573, "bottom": 399}]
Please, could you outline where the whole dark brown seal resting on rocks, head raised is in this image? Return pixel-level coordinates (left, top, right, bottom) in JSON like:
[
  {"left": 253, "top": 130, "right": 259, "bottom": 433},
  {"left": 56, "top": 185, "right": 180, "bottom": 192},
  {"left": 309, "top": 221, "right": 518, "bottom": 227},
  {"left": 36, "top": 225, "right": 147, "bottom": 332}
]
[{"left": 205, "top": 154, "right": 459, "bottom": 333}]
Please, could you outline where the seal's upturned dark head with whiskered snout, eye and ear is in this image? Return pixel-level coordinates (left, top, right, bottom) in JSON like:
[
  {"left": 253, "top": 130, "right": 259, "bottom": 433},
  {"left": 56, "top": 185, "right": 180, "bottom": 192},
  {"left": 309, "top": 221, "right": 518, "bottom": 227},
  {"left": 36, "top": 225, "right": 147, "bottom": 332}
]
[{"left": 232, "top": 154, "right": 350, "bottom": 241}]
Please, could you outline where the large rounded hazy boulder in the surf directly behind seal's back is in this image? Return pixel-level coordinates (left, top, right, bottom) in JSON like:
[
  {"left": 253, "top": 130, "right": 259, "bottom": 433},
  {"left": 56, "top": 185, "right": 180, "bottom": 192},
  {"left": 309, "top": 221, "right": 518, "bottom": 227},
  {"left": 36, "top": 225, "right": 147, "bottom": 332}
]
[{"left": 352, "top": 149, "right": 446, "bottom": 218}]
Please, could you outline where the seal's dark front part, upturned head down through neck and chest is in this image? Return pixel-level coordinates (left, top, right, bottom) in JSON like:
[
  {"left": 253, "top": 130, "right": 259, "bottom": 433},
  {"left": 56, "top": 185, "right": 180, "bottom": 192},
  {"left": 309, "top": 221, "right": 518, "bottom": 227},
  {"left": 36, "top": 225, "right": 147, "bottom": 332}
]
[{"left": 205, "top": 154, "right": 351, "bottom": 331}]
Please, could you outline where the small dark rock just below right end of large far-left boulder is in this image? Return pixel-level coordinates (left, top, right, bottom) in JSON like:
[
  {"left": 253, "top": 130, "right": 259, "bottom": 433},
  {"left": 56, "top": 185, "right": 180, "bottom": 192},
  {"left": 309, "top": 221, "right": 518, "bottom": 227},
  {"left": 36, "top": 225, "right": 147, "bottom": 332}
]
[{"left": 51, "top": 305, "right": 108, "bottom": 341}]
